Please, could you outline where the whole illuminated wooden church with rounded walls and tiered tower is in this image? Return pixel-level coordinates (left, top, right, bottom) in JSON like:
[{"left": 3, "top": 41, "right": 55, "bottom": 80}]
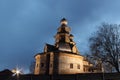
[{"left": 34, "top": 18, "right": 93, "bottom": 75}]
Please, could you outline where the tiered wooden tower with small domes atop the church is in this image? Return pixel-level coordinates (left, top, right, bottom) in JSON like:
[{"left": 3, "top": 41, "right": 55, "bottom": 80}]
[{"left": 55, "top": 18, "right": 78, "bottom": 54}]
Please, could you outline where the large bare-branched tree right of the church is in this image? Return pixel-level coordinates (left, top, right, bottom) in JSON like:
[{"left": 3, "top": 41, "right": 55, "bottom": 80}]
[{"left": 89, "top": 23, "right": 120, "bottom": 72}]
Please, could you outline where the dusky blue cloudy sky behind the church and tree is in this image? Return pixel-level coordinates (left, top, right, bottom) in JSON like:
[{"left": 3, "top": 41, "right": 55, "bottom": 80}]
[{"left": 0, "top": 0, "right": 120, "bottom": 71}]
